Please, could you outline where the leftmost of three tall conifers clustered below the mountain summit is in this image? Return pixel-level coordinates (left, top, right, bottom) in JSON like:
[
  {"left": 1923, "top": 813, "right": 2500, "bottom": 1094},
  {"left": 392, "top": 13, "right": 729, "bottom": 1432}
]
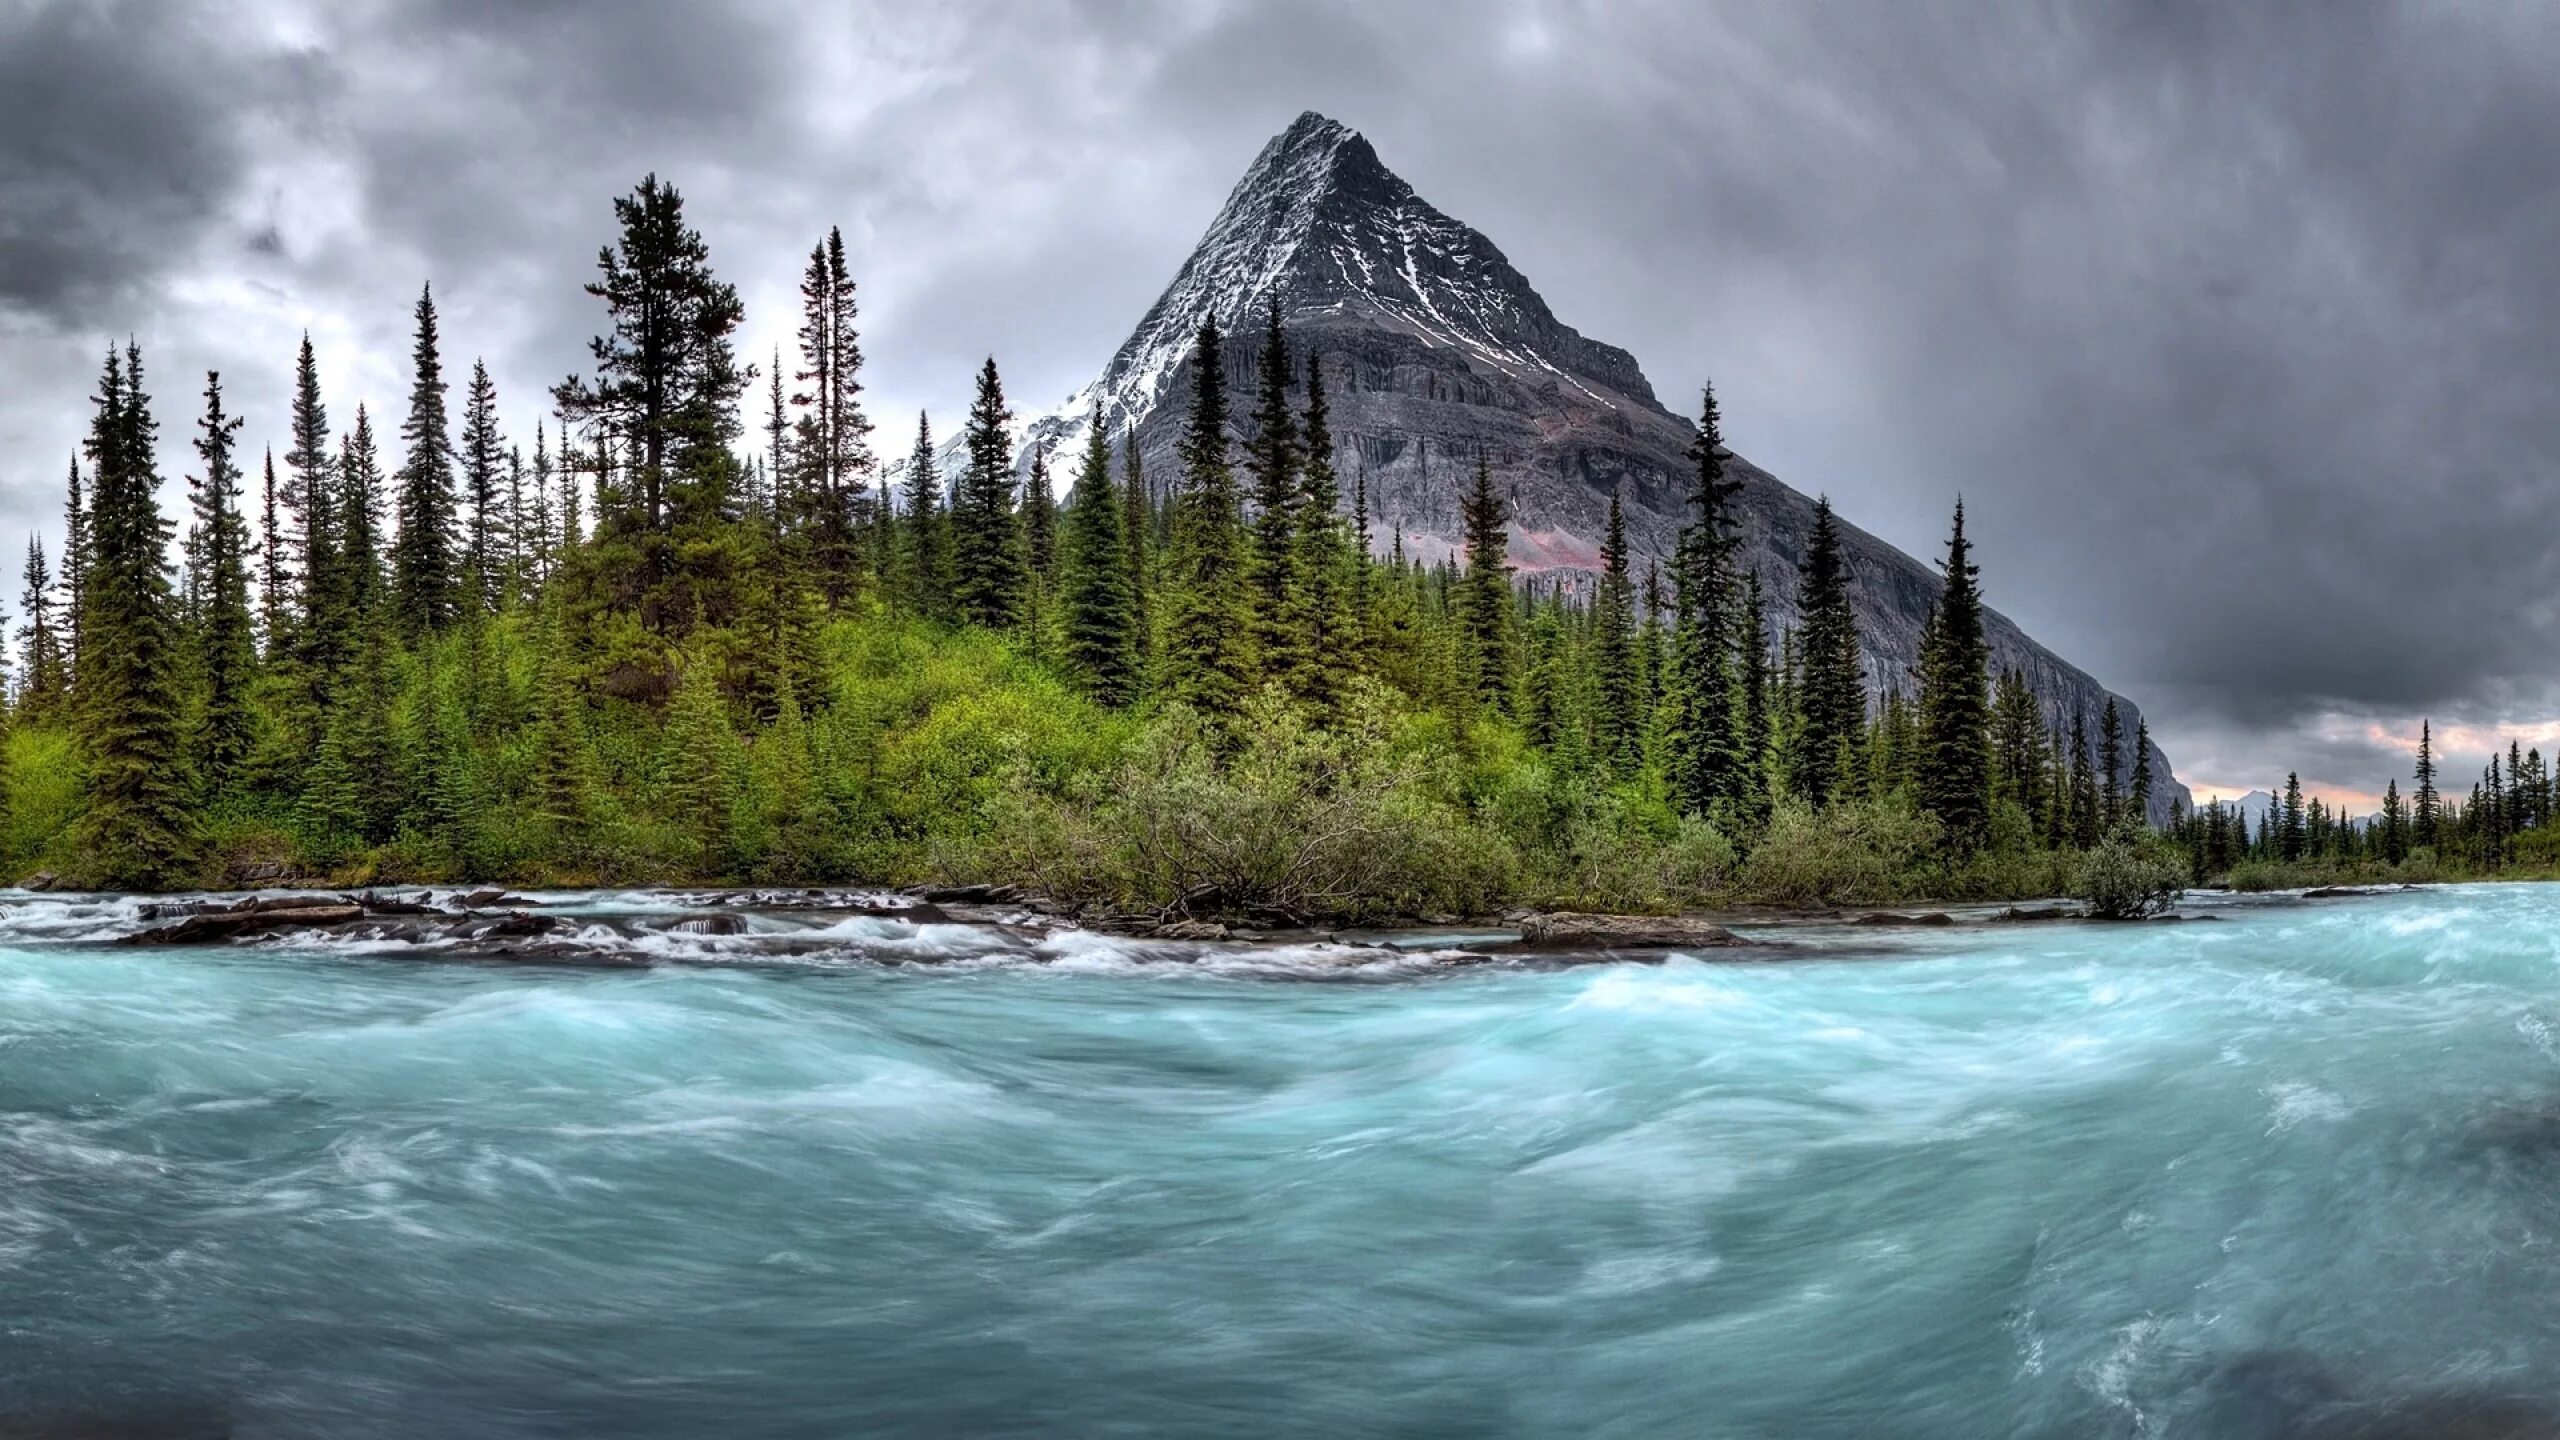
[{"left": 1162, "top": 320, "right": 1252, "bottom": 717}]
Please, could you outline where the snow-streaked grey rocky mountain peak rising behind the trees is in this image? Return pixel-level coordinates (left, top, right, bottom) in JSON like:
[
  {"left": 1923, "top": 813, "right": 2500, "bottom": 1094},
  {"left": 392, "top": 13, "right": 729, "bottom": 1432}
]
[{"left": 993, "top": 113, "right": 2186, "bottom": 817}]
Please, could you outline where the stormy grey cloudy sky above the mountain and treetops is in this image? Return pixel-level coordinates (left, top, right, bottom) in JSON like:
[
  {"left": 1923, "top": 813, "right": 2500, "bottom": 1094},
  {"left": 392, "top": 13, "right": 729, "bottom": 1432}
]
[{"left": 0, "top": 0, "right": 2560, "bottom": 799}]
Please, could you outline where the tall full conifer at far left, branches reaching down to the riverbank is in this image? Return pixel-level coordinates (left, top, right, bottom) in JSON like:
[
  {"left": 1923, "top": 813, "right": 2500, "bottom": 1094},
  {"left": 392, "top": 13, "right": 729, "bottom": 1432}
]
[{"left": 79, "top": 343, "right": 197, "bottom": 889}]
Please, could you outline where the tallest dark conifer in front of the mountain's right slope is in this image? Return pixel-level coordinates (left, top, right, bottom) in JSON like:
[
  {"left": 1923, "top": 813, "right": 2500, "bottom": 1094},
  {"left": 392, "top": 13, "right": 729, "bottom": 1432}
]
[{"left": 1669, "top": 387, "right": 1741, "bottom": 815}]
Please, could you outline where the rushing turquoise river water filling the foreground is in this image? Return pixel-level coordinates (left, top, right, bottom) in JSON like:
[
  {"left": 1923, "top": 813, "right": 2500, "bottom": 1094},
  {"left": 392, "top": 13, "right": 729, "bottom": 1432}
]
[{"left": 0, "top": 887, "right": 2560, "bottom": 1437}]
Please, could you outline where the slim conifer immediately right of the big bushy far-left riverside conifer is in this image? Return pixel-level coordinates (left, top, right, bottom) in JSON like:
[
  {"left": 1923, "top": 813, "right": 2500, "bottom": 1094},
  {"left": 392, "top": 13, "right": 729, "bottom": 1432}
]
[{"left": 189, "top": 372, "right": 259, "bottom": 797}]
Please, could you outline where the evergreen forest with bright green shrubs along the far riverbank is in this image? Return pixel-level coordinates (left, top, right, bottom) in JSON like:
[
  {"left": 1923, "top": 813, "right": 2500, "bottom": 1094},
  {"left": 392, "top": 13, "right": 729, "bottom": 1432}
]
[{"left": 0, "top": 177, "right": 2519, "bottom": 922}]
